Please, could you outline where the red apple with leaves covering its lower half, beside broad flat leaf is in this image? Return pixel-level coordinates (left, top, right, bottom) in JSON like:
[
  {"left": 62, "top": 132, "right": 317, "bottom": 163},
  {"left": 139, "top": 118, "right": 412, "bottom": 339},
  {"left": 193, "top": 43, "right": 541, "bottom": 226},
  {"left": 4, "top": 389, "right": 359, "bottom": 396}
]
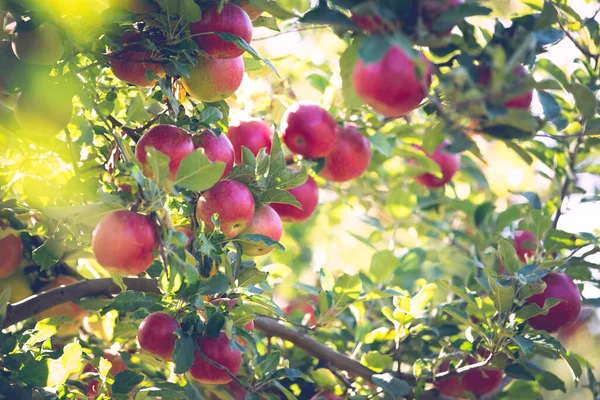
[{"left": 135, "top": 125, "right": 194, "bottom": 180}]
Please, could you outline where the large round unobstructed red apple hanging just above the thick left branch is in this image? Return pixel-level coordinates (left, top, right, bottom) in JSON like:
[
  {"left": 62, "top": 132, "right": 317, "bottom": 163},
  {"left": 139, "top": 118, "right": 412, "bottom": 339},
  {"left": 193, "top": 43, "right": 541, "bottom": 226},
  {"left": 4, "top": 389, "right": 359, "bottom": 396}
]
[{"left": 92, "top": 210, "right": 158, "bottom": 275}]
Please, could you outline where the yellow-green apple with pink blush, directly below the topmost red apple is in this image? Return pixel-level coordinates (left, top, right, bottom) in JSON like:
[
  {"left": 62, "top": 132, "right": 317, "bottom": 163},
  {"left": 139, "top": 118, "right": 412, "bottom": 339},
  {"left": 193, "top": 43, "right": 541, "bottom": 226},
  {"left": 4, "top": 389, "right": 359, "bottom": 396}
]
[{"left": 181, "top": 57, "right": 244, "bottom": 103}]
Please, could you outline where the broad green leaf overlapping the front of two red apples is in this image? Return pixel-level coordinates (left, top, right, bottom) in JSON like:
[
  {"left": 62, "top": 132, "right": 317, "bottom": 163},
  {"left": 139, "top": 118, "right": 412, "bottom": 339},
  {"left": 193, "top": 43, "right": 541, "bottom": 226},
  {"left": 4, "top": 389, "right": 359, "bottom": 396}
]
[{"left": 175, "top": 149, "right": 225, "bottom": 192}]
